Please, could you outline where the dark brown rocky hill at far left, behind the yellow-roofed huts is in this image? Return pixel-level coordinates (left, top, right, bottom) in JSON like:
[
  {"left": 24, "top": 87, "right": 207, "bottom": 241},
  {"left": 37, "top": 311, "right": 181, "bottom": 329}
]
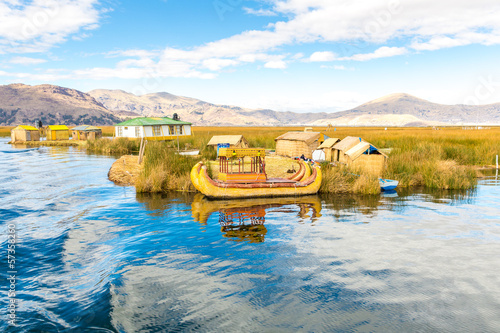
[{"left": 0, "top": 83, "right": 120, "bottom": 125}]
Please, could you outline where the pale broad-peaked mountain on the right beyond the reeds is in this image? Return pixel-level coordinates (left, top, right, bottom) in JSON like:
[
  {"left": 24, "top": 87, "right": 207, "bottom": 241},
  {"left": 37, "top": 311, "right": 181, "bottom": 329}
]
[{"left": 313, "top": 93, "right": 500, "bottom": 126}]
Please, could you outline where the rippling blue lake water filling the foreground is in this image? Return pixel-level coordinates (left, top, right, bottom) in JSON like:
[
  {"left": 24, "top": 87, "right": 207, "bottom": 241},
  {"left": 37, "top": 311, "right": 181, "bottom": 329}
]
[{"left": 0, "top": 138, "right": 500, "bottom": 332}]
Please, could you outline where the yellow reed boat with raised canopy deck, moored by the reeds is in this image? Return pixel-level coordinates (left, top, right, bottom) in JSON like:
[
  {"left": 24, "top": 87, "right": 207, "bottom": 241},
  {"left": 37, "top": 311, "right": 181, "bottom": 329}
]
[{"left": 191, "top": 148, "right": 322, "bottom": 199}]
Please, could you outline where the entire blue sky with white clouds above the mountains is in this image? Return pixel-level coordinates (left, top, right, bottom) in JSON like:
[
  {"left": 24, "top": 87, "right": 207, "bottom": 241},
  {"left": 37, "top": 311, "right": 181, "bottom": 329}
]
[{"left": 0, "top": 0, "right": 500, "bottom": 112}]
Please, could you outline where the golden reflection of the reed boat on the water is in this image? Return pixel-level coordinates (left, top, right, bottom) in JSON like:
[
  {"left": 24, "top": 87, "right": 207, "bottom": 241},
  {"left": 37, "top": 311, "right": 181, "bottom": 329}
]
[{"left": 191, "top": 194, "right": 321, "bottom": 243}]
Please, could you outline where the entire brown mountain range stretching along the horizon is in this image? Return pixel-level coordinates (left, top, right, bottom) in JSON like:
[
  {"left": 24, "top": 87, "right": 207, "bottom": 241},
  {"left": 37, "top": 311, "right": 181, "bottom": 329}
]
[{"left": 0, "top": 83, "right": 500, "bottom": 126}]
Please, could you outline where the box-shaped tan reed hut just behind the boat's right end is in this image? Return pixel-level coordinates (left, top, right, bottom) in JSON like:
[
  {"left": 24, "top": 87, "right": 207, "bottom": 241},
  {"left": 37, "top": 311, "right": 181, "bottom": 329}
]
[{"left": 274, "top": 132, "right": 325, "bottom": 158}]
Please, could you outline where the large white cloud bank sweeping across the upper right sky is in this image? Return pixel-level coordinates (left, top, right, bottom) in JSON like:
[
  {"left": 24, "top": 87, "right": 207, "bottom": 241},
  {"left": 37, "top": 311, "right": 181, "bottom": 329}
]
[{"left": 124, "top": 0, "right": 500, "bottom": 78}]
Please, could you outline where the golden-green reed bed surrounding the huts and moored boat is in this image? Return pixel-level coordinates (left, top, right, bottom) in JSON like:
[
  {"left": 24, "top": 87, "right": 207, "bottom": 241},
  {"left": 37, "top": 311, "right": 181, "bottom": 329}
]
[{"left": 102, "top": 127, "right": 500, "bottom": 194}]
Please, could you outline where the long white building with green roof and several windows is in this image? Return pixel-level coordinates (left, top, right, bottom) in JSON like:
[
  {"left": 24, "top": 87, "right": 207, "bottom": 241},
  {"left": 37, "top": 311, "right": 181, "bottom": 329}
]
[{"left": 115, "top": 117, "right": 191, "bottom": 140}]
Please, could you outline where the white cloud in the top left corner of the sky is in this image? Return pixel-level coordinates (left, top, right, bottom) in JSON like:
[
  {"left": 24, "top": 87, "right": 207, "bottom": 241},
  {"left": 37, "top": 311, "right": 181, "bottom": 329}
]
[{"left": 0, "top": 0, "right": 104, "bottom": 53}]
